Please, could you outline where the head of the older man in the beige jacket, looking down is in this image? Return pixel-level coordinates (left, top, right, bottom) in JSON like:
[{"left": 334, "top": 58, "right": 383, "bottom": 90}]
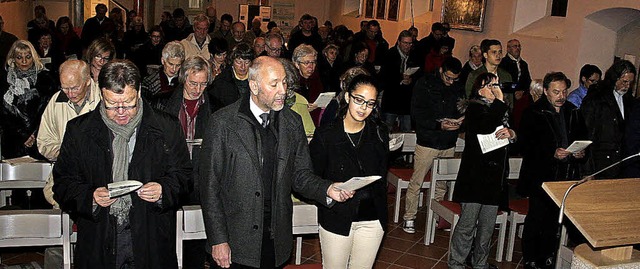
[{"left": 59, "top": 60, "right": 91, "bottom": 105}]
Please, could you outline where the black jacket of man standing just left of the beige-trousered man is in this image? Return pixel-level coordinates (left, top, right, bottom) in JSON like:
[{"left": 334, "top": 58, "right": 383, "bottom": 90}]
[{"left": 380, "top": 46, "right": 424, "bottom": 115}]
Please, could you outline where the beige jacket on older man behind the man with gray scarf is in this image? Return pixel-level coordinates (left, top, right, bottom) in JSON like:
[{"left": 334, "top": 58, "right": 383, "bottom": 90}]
[{"left": 37, "top": 80, "right": 101, "bottom": 208}]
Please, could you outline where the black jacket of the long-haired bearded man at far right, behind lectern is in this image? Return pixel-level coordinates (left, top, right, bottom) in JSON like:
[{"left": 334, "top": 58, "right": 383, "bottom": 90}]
[{"left": 580, "top": 87, "right": 633, "bottom": 178}]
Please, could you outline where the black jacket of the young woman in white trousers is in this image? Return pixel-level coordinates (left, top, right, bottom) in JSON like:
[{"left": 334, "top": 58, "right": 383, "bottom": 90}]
[{"left": 309, "top": 119, "right": 389, "bottom": 236}]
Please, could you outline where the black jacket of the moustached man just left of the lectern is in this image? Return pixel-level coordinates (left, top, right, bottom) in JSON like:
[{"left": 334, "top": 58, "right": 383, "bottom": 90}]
[{"left": 517, "top": 96, "right": 587, "bottom": 196}]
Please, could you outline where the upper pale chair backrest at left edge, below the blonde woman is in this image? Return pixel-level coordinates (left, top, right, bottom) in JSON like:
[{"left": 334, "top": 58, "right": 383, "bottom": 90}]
[{"left": 0, "top": 162, "right": 52, "bottom": 189}]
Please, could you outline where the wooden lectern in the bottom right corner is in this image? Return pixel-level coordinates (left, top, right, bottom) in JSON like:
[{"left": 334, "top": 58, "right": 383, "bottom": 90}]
[{"left": 542, "top": 179, "right": 640, "bottom": 267}]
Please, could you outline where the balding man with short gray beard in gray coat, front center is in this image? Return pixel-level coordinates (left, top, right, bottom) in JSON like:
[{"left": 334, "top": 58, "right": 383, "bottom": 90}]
[{"left": 200, "top": 56, "right": 353, "bottom": 268}]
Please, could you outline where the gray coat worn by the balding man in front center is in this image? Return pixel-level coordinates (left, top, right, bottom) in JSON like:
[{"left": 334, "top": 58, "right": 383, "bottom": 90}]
[{"left": 200, "top": 98, "right": 331, "bottom": 267}]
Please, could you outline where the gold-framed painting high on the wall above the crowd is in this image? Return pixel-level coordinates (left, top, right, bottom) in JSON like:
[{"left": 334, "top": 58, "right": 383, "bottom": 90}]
[{"left": 440, "top": 0, "right": 487, "bottom": 32}]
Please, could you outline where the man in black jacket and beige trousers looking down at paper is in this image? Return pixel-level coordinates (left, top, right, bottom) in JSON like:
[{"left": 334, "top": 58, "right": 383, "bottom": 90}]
[{"left": 402, "top": 57, "right": 465, "bottom": 234}]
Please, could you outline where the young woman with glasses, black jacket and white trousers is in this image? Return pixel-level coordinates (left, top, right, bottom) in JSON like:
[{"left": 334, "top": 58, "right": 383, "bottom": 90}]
[{"left": 309, "top": 75, "right": 389, "bottom": 268}]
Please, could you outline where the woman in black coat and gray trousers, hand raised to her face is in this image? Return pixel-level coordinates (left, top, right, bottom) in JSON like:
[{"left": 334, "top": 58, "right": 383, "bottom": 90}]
[{"left": 449, "top": 73, "right": 516, "bottom": 269}]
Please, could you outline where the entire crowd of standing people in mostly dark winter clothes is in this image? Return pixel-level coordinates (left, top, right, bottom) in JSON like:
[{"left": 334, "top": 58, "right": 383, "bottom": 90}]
[{"left": 0, "top": 4, "right": 640, "bottom": 268}]
